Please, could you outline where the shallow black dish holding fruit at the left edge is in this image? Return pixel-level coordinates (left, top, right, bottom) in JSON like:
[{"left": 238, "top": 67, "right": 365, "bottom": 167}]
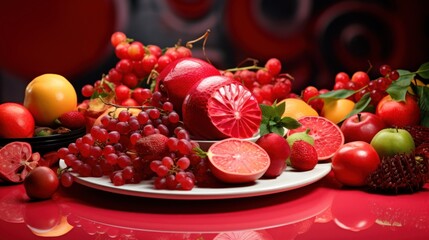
[{"left": 0, "top": 127, "right": 86, "bottom": 154}]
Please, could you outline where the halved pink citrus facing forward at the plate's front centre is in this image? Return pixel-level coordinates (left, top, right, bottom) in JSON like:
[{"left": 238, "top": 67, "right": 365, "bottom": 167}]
[{"left": 207, "top": 138, "right": 270, "bottom": 183}]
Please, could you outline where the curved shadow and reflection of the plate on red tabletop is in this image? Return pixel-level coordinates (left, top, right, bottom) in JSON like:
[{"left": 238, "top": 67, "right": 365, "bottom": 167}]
[{"left": 56, "top": 179, "right": 333, "bottom": 233}]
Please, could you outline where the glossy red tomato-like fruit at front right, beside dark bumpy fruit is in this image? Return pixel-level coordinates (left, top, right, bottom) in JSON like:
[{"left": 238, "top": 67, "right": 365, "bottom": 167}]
[{"left": 332, "top": 141, "right": 380, "bottom": 187}]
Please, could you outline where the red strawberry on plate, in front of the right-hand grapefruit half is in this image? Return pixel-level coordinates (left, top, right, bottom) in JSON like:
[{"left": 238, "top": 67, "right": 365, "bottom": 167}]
[{"left": 290, "top": 140, "right": 318, "bottom": 171}]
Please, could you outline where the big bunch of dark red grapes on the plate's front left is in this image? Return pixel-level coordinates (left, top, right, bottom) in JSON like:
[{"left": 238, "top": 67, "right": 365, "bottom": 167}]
[{"left": 57, "top": 92, "right": 214, "bottom": 190}]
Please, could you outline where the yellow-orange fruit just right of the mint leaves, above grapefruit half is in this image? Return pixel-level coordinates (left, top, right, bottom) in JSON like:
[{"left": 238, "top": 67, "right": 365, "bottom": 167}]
[{"left": 278, "top": 98, "right": 319, "bottom": 119}]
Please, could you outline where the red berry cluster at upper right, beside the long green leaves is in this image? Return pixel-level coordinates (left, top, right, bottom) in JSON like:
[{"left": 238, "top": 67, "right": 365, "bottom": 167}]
[{"left": 334, "top": 65, "right": 399, "bottom": 106}]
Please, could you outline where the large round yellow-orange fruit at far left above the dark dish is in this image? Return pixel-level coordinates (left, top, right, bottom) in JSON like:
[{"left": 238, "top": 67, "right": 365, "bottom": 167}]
[{"left": 24, "top": 74, "right": 77, "bottom": 126}]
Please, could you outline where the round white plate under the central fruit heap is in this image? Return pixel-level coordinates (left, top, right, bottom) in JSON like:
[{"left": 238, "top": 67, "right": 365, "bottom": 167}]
[{"left": 60, "top": 160, "right": 331, "bottom": 200}]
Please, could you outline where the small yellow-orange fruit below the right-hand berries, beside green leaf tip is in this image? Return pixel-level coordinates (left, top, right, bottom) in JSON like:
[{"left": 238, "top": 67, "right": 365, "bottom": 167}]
[{"left": 320, "top": 99, "right": 355, "bottom": 124}]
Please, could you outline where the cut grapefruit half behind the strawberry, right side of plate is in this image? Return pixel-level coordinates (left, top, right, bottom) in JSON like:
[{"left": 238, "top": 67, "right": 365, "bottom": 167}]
[{"left": 288, "top": 116, "right": 344, "bottom": 161}]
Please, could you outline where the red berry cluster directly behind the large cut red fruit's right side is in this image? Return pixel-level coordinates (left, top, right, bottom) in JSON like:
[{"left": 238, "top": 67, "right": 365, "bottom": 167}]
[{"left": 224, "top": 58, "right": 293, "bottom": 105}]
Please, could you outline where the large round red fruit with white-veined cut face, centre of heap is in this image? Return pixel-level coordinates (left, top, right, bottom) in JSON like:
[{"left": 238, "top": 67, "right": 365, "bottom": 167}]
[{"left": 182, "top": 76, "right": 262, "bottom": 140}]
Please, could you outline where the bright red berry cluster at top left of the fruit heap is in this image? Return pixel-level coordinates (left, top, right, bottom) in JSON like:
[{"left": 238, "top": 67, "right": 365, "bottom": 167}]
[{"left": 81, "top": 32, "right": 192, "bottom": 106}]
